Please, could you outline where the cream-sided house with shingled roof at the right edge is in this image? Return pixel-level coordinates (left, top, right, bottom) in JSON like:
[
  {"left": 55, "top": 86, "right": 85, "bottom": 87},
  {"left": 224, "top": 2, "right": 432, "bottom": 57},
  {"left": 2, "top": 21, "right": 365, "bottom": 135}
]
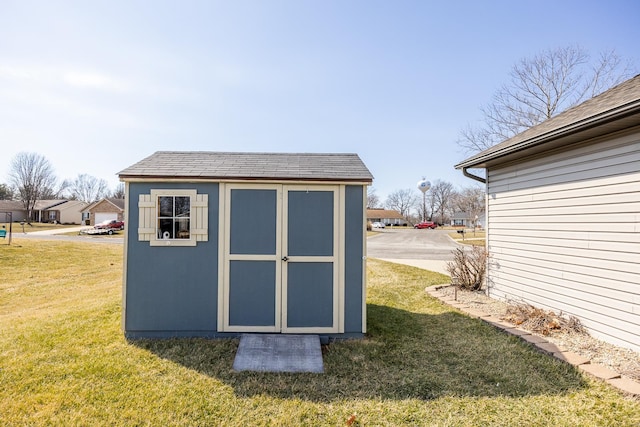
[{"left": 456, "top": 75, "right": 640, "bottom": 351}]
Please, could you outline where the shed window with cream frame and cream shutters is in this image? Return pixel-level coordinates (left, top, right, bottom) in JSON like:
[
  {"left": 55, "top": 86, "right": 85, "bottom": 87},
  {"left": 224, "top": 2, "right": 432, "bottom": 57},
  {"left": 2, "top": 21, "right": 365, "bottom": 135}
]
[{"left": 138, "top": 189, "right": 209, "bottom": 246}]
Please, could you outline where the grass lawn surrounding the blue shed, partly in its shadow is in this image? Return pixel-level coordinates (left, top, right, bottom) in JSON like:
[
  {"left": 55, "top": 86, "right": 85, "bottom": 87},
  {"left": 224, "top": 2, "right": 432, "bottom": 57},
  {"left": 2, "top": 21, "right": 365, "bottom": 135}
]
[{"left": 0, "top": 239, "right": 640, "bottom": 426}]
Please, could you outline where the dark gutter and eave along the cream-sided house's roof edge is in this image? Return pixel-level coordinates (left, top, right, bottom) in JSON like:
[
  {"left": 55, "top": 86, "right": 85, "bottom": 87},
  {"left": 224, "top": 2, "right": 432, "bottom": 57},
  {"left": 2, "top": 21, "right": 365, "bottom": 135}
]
[{"left": 454, "top": 100, "right": 640, "bottom": 170}]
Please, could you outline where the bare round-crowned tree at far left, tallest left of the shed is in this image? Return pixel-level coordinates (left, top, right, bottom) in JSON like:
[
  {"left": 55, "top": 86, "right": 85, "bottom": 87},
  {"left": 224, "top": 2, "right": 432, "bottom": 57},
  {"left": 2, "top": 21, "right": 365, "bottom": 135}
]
[{"left": 9, "top": 152, "right": 57, "bottom": 220}]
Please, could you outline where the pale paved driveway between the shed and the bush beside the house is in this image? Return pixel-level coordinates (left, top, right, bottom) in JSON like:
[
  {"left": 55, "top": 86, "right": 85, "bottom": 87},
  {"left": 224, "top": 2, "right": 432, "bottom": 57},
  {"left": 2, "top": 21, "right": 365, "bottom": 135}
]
[{"left": 367, "top": 228, "right": 460, "bottom": 275}]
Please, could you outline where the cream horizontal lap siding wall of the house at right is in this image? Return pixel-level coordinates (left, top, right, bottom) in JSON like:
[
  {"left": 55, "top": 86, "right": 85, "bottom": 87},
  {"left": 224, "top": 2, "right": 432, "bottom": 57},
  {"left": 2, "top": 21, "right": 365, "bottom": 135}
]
[{"left": 487, "top": 130, "right": 640, "bottom": 351}]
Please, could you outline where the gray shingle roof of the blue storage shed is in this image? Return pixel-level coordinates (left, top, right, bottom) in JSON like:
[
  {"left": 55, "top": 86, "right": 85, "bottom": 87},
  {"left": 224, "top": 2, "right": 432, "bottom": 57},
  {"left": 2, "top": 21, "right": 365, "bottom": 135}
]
[{"left": 118, "top": 151, "right": 373, "bottom": 182}]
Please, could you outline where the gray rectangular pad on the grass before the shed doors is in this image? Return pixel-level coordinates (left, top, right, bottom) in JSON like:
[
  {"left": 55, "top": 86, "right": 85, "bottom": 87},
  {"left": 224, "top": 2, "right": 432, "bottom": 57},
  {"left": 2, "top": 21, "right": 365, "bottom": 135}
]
[{"left": 233, "top": 334, "right": 324, "bottom": 373}]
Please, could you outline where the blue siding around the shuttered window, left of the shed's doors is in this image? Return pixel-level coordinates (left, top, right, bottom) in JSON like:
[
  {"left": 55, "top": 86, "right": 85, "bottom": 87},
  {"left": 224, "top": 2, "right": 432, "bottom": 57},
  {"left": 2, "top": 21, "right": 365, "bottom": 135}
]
[{"left": 124, "top": 182, "right": 219, "bottom": 336}]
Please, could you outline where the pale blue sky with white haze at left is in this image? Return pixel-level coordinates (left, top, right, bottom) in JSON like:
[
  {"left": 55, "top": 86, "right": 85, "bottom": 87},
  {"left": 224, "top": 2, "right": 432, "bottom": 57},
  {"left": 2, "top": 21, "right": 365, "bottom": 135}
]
[{"left": 0, "top": 0, "right": 640, "bottom": 200}]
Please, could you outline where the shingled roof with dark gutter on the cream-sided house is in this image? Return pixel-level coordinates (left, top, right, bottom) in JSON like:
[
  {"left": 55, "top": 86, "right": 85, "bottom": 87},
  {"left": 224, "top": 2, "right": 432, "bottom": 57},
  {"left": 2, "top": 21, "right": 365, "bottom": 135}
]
[{"left": 455, "top": 74, "right": 640, "bottom": 169}]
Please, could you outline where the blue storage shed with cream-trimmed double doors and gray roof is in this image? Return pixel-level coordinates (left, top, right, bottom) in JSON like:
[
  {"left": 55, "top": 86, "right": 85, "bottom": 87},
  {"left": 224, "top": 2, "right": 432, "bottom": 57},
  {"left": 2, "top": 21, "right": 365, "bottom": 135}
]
[{"left": 119, "top": 151, "right": 373, "bottom": 338}]
